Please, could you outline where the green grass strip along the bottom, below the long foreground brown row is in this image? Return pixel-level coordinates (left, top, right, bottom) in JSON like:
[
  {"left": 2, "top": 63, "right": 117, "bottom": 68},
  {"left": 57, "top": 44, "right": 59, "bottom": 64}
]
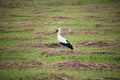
[{"left": 0, "top": 68, "right": 120, "bottom": 80}]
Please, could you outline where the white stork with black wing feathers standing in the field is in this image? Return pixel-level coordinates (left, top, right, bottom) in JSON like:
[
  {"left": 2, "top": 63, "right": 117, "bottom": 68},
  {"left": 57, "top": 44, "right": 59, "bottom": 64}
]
[{"left": 56, "top": 28, "right": 73, "bottom": 50}]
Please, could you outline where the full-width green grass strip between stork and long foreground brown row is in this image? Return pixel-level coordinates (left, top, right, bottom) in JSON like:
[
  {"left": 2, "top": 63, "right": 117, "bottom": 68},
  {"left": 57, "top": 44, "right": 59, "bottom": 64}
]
[{"left": 0, "top": 48, "right": 120, "bottom": 64}]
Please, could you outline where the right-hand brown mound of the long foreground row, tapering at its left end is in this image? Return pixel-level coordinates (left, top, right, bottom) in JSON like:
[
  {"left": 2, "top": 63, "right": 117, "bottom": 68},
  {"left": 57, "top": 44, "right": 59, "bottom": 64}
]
[{"left": 49, "top": 60, "right": 120, "bottom": 70}]
